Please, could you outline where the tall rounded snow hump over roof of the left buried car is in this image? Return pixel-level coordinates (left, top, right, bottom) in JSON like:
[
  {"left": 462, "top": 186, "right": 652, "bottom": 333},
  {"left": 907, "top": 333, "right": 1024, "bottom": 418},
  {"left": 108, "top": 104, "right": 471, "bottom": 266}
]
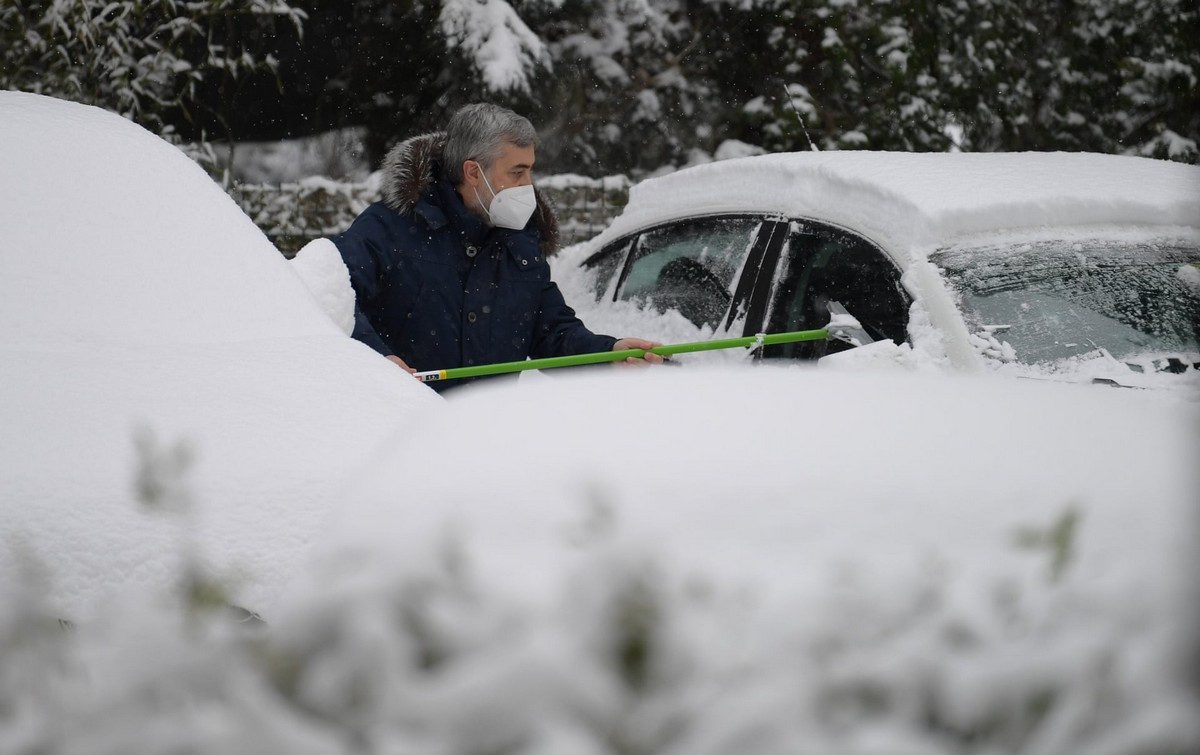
[{"left": 0, "top": 92, "right": 334, "bottom": 346}]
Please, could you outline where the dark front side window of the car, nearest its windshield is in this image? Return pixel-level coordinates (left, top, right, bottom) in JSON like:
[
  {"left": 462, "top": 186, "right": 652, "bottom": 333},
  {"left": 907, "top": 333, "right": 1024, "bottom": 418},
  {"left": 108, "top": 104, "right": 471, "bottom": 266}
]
[{"left": 763, "top": 223, "right": 912, "bottom": 359}]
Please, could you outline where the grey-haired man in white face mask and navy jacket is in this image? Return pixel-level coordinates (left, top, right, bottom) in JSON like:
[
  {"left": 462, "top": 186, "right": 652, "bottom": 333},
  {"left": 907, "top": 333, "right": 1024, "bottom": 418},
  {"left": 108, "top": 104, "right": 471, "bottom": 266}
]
[{"left": 334, "top": 104, "right": 662, "bottom": 391}]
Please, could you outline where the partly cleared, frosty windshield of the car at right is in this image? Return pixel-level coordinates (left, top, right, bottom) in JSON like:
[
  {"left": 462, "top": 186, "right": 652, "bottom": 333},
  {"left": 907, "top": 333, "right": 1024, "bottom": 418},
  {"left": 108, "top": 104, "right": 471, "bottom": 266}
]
[{"left": 931, "top": 240, "right": 1200, "bottom": 364}]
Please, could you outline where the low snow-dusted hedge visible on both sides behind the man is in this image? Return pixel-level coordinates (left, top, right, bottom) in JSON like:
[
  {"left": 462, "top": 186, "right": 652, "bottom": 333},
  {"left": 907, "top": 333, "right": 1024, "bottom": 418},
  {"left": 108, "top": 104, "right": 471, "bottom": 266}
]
[{"left": 229, "top": 173, "right": 630, "bottom": 257}]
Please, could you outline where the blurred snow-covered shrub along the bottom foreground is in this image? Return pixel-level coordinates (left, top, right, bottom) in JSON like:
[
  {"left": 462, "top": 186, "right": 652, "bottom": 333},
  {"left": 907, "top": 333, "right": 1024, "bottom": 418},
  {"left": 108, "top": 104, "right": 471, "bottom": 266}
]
[{"left": 0, "top": 501, "right": 1200, "bottom": 755}]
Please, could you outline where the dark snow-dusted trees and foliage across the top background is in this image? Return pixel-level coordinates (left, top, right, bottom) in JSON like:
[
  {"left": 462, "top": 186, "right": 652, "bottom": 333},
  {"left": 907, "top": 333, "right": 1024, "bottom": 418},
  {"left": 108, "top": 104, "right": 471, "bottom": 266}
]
[{"left": 0, "top": 0, "right": 1200, "bottom": 172}]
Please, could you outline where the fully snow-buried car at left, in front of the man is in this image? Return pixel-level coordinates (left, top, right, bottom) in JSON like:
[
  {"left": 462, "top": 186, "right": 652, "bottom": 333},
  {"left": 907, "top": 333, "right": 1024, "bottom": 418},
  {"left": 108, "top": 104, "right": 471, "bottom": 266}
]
[{"left": 0, "top": 92, "right": 438, "bottom": 619}]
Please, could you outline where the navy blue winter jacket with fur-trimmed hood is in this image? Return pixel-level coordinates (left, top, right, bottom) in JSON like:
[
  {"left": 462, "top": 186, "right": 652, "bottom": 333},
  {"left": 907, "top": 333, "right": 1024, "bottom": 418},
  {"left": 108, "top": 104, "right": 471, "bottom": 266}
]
[{"left": 334, "top": 134, "right": 616, "bottom": 390}]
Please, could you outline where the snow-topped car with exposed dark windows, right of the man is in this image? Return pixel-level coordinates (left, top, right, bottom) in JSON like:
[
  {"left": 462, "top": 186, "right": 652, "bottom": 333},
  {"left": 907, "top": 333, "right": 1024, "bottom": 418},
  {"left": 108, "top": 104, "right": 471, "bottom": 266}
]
[{"left": 556, "top": 152, "right": 1200, "bottom": 384}]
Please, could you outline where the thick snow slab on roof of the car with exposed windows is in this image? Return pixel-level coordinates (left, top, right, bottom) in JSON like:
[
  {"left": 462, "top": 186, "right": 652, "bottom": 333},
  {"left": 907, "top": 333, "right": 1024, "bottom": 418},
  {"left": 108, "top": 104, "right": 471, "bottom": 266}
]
[{"left": 596, "top": 151, "right": 1200, "bottom": 254}]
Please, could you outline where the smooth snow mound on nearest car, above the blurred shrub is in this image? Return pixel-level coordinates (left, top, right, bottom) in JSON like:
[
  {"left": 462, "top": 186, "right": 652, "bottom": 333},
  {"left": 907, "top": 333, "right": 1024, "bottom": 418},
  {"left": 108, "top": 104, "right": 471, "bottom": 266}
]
[{"left": 314, "top": 366, "right": 1200, "bottom": 612}]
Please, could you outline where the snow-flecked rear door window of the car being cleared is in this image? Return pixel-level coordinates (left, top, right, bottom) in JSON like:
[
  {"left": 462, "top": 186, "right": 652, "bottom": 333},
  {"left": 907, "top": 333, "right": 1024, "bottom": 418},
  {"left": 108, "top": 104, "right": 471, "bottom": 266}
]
[{"left": 617, "top": 217, "right": 763, "bottom": 328}]
